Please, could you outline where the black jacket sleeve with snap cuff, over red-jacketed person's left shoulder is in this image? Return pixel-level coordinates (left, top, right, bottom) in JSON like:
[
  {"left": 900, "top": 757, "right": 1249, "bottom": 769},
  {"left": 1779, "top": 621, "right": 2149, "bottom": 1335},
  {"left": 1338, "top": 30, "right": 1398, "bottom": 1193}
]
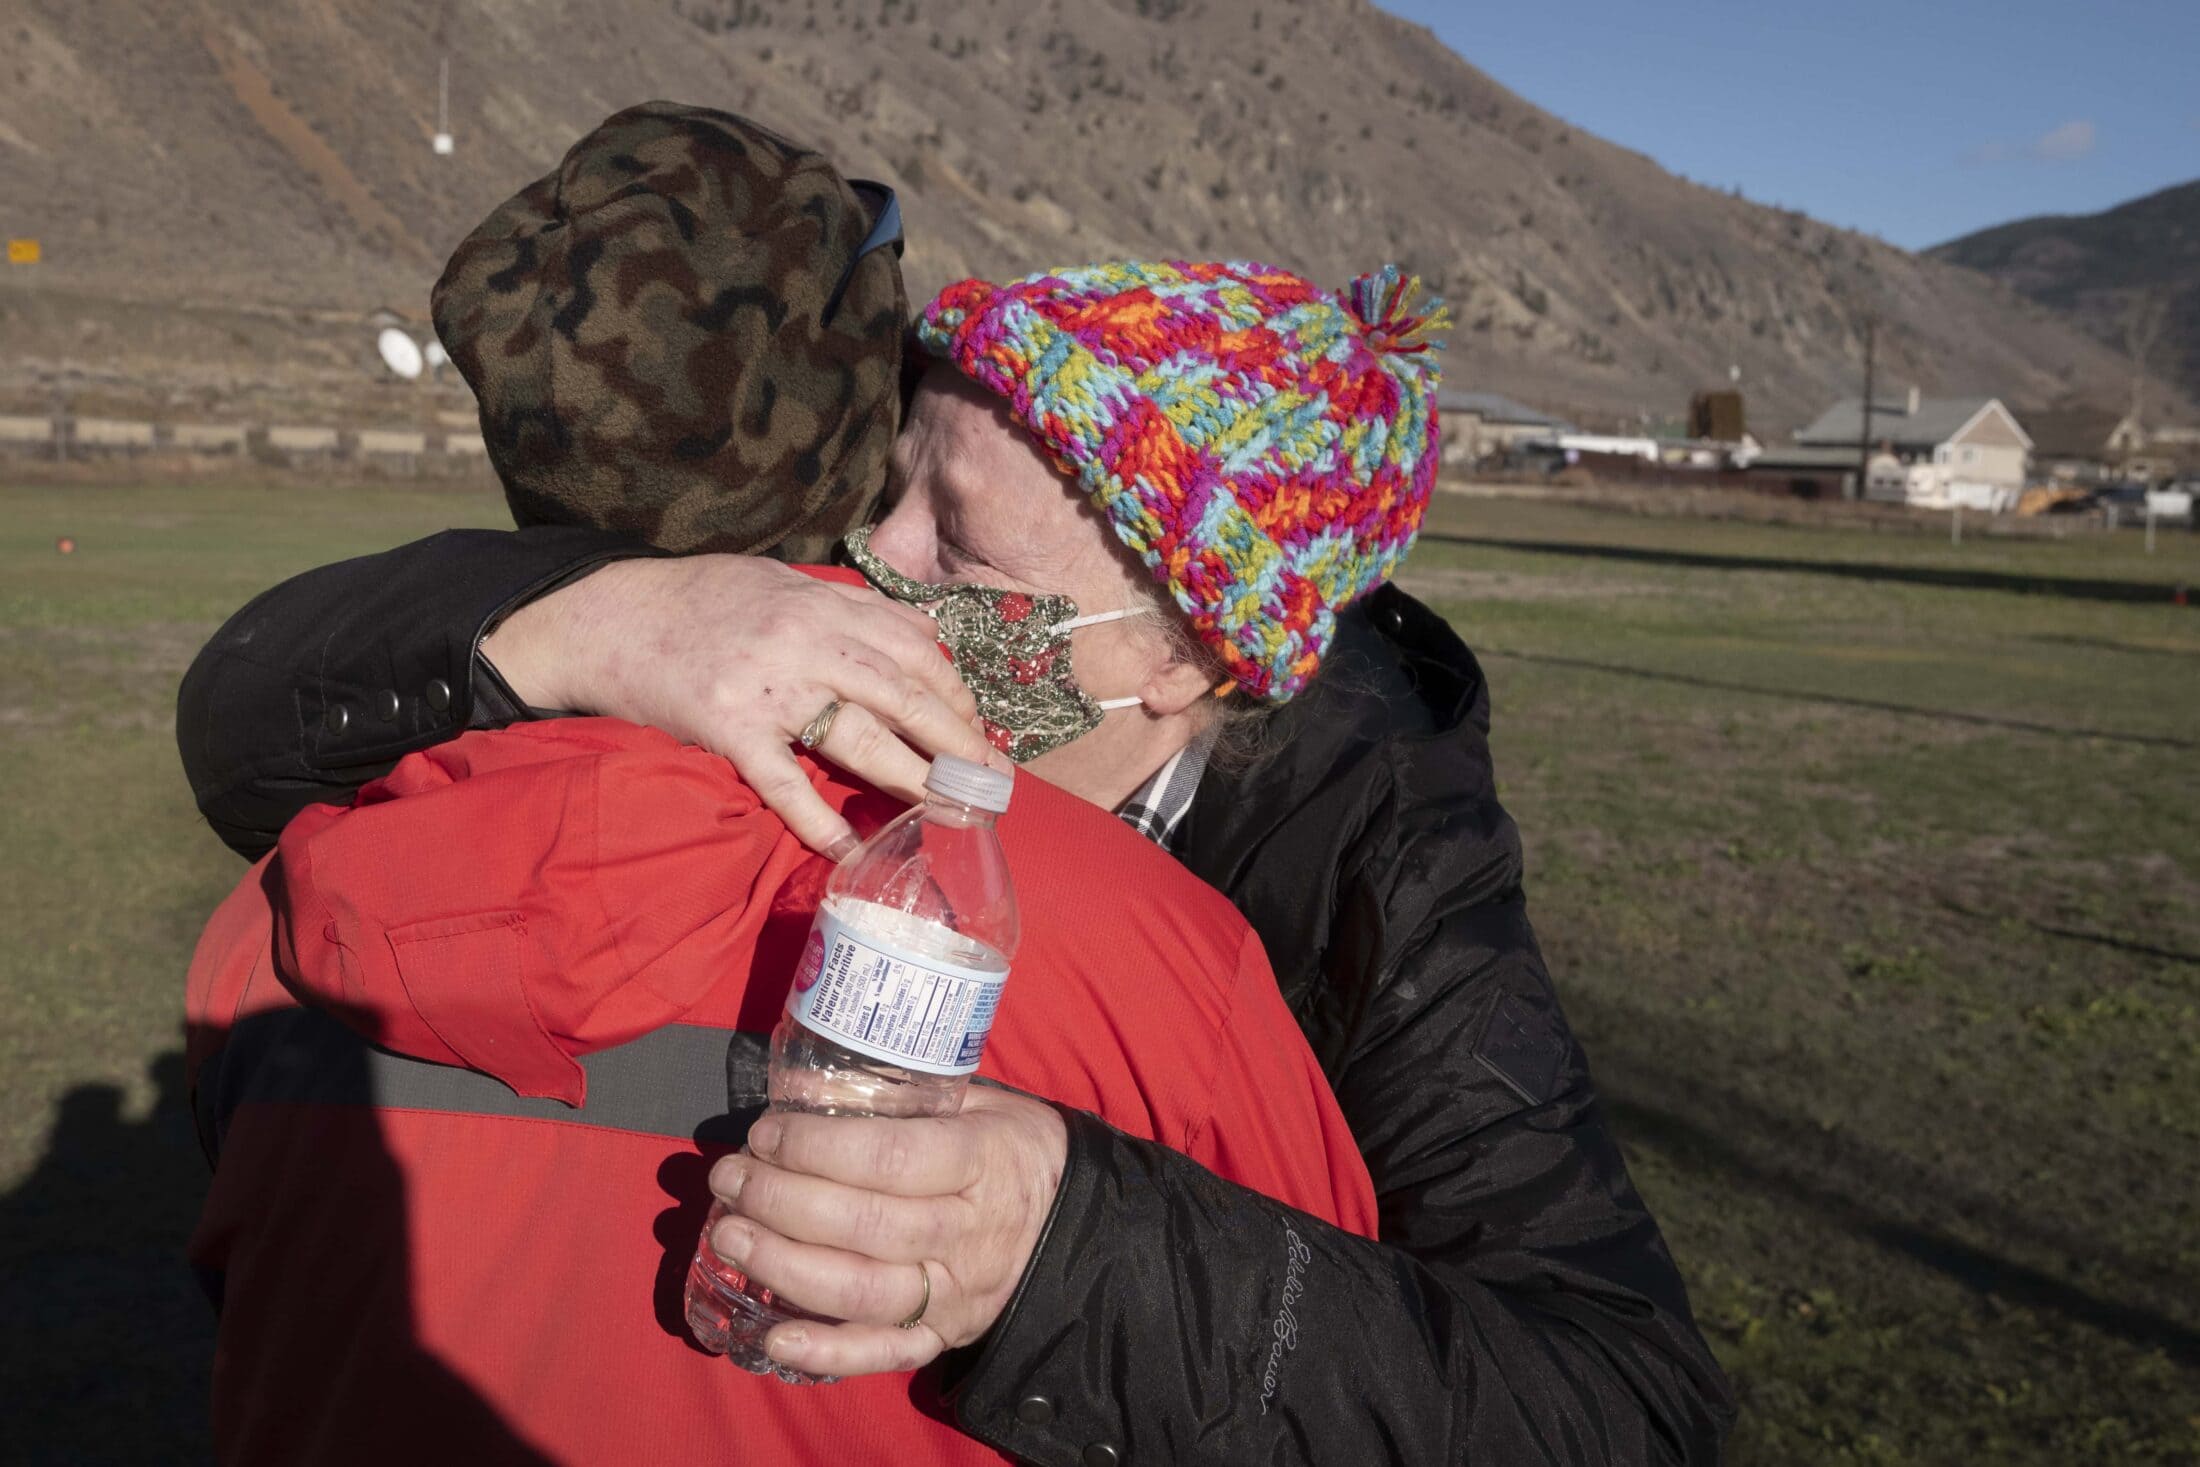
[{"left": 176, "top": 526, "right": 656, "bottom": 860}]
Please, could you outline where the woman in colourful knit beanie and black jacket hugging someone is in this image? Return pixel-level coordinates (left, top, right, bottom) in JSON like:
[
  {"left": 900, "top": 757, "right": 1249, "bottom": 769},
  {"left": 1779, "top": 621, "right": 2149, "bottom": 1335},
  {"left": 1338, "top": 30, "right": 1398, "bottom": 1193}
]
[{"left": 178, "top": 123, "right": 1734, "bottom": 1467}]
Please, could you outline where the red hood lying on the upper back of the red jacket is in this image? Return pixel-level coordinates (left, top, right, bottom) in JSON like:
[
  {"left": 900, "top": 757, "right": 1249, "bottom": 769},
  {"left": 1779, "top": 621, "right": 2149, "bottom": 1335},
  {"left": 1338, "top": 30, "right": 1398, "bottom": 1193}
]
[{"left": 266, "top": 719, "right": 810, "bottom": 1104}]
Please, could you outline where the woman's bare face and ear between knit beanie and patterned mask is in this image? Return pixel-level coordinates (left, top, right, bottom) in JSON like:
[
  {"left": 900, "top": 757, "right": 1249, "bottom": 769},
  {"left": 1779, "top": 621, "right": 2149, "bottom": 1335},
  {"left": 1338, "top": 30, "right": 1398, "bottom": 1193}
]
[{"left": 871, "top": 365, "right": 1166, "bottom": 712}]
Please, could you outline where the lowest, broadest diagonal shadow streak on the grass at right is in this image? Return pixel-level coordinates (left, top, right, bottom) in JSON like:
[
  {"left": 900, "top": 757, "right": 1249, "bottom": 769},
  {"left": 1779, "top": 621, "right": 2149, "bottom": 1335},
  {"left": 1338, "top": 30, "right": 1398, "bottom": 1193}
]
[{"left": 1604, "top": 1084, "right": 2200, "bottom": 1366}]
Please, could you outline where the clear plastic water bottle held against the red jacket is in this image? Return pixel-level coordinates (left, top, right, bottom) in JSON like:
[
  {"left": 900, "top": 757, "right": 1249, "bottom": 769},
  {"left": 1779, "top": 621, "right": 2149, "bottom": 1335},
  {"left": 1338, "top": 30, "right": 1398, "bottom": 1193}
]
[{"left": 686, "top": 754, "right": 1016, "bottom": 1383}]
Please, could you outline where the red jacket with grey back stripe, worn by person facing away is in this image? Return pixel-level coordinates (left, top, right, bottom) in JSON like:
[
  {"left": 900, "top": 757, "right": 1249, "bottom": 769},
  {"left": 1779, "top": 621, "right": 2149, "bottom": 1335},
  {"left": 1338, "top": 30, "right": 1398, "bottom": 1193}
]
[{"left": 189, "top": 719, "right": 1375, "bottom": 1467}]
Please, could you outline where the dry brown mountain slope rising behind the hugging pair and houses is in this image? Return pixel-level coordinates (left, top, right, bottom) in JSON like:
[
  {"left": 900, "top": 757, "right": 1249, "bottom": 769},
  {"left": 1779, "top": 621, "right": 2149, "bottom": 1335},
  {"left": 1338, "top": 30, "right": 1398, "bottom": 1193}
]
[{"left": 0, "top": 0, "right": 2164, "bottom": 427}]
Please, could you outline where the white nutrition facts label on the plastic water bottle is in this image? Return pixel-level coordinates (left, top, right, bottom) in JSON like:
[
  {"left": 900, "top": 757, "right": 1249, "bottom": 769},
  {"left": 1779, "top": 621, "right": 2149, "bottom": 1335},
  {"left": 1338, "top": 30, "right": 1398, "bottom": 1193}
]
[{"left": 792, "top": 913, "right": 1008, "bottom": 1076}]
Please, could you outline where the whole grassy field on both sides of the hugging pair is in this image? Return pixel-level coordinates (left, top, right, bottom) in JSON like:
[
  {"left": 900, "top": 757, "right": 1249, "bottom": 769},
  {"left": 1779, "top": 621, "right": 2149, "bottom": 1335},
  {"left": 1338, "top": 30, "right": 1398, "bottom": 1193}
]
[{"left": 0, "top": 488, "right": 2200, "bottom": 1465}]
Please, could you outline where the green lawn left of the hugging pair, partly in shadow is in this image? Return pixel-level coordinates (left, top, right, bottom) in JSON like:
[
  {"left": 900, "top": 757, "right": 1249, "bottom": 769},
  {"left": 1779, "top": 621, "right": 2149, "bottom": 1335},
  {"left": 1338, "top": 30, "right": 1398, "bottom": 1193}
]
[{"left": 0, "top": 486, "right": 510, "bottom": 1465}]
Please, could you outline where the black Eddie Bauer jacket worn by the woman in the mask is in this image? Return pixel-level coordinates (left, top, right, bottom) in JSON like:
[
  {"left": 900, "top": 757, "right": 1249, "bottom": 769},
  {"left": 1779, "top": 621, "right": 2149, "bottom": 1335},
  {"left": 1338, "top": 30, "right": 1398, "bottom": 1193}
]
[{"left": 178, "top": 530, "right": 1731, "bottom": 1467}]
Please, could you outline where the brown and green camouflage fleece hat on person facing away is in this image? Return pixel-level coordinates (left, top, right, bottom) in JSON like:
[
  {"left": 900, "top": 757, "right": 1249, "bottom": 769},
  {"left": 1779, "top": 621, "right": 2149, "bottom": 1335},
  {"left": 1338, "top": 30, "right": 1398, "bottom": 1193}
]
[{"left": 433, "top": 101, "right": 909, "bottom": 561}]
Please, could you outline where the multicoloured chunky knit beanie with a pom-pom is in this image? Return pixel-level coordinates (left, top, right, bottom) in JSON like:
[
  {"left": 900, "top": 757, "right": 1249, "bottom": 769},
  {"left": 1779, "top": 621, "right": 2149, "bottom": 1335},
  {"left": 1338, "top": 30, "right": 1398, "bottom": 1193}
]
[{"left": 917, "top": 262, "right": 1450, "bottom": 702}]
